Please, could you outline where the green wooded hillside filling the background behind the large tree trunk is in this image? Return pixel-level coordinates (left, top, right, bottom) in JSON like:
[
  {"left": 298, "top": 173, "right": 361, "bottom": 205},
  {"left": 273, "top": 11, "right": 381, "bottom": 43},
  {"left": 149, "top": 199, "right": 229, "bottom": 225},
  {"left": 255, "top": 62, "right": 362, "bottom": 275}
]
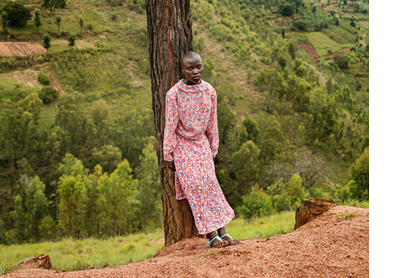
[{"left": 0, "top": 0, "right": 369, "bottom": 243}]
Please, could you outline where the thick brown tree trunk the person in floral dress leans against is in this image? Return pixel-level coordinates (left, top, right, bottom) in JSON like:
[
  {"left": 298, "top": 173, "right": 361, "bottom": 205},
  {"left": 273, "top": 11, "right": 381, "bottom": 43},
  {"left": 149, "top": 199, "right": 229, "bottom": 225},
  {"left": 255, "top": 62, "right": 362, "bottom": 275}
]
[{"left": 146, "top": 0, "right": 198, "bottom": 246}]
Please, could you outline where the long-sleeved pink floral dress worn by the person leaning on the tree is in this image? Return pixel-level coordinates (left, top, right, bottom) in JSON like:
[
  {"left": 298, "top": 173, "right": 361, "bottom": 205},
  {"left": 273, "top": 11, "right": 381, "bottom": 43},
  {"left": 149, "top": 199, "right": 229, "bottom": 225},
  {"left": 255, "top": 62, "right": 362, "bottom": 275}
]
[{"left": 163, "top": 80, "right": 235, "bottom": 234}]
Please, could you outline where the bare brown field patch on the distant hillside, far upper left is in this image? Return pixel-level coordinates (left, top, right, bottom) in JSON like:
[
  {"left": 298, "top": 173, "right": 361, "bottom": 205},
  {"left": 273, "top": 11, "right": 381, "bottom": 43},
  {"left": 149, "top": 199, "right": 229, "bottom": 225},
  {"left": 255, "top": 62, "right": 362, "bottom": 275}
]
[{"left": 0, "top": 42, "right": 47, "bottom": 57}]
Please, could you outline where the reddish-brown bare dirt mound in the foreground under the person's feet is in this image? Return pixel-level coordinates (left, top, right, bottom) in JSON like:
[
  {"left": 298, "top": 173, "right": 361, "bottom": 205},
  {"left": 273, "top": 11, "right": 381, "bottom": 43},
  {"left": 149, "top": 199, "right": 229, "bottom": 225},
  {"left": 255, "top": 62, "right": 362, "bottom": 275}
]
[{"left": 5, "top": 206, "right": 369, "bottom": 278}]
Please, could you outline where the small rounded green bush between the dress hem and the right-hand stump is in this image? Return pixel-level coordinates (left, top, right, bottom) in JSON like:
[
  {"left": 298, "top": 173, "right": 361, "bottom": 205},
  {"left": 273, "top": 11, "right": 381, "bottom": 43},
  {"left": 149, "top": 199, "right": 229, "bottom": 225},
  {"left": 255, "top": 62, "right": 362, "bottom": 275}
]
[{"left": 239, "top": 185, "right": 273, "bottom": 219}]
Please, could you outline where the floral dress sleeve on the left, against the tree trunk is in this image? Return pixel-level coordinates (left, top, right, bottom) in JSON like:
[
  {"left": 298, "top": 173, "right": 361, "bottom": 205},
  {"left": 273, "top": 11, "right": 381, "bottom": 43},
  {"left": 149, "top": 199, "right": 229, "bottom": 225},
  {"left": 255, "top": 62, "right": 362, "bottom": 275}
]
[{"left": 163, "top": 90, "right": 179, "bottom": 161}]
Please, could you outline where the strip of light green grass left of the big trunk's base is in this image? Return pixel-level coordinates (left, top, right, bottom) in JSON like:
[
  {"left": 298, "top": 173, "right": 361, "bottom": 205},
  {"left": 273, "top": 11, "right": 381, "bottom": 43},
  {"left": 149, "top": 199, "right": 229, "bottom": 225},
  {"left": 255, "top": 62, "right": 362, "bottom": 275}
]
[{"left": 0, "top": 229, "right": 164, "bottom": 273}]
